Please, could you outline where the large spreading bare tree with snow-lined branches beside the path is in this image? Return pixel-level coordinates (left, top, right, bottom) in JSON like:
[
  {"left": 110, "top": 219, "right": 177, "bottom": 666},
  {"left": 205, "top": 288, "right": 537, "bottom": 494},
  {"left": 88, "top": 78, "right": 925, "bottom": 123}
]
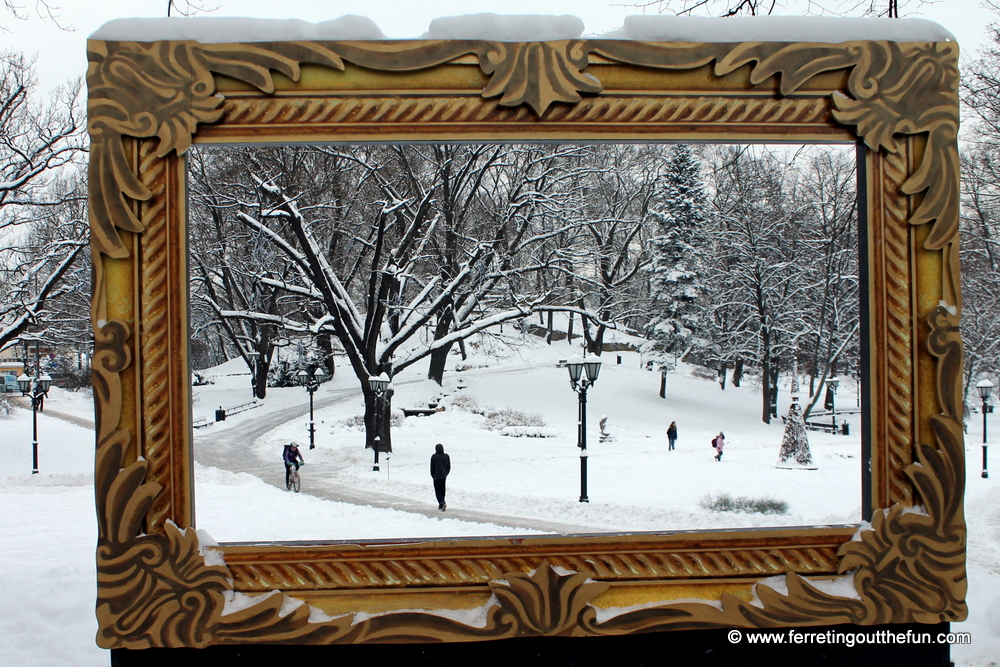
[{"left": 192, "top": 145, "right": 568, "bottom": 451}]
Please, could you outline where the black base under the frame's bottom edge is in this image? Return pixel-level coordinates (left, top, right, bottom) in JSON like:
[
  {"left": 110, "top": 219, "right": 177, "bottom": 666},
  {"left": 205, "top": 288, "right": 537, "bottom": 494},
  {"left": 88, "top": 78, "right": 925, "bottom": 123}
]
[{"left": 111, "top": 623, "right": 951, "bottom": 667}]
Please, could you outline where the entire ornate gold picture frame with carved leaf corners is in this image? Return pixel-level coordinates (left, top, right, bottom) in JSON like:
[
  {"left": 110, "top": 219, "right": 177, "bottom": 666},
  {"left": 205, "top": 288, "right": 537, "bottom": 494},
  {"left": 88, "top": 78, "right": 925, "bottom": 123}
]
[{"left": 88, "top": 28, "right": 966, "bottom": 648}]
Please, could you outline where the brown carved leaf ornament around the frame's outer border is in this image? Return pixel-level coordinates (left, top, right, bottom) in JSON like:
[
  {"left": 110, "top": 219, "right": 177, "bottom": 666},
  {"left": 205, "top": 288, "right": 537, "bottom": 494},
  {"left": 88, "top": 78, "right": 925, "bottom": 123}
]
[{"left": 88, "top": 32, "right": 966, "bottom": 648}]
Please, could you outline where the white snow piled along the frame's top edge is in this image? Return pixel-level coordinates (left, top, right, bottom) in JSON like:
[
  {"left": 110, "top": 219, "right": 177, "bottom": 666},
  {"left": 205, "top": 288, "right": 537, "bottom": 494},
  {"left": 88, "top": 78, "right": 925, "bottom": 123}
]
[{"left": 90, "top": 13, "right": 955, "bottom": 44}]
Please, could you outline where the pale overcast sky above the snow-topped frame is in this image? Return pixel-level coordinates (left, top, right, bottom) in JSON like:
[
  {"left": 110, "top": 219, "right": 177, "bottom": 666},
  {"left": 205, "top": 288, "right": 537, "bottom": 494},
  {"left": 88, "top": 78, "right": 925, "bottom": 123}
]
[{"left": 0, "top": 0, "right": 1000, "bottom": 88}]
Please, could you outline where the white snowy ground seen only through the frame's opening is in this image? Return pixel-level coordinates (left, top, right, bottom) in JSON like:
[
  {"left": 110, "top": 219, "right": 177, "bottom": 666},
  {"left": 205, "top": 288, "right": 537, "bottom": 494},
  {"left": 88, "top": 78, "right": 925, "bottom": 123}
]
[{"left": 195, "top": 326, "right": 861, "bottom": 542}]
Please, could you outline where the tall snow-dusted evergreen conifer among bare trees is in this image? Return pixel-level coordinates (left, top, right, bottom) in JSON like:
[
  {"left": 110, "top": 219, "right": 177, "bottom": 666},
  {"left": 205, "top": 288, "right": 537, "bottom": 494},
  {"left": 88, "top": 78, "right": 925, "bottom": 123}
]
[{"left": 643, "top": 144, "right": 708, "bottom": 371}]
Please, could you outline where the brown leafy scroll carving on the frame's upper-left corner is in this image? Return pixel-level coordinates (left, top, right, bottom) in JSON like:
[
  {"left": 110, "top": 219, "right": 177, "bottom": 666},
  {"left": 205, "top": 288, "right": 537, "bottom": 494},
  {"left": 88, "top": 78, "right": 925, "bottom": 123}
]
[{"left": 87, "top": 41, "right": 344, "bottom": 259}]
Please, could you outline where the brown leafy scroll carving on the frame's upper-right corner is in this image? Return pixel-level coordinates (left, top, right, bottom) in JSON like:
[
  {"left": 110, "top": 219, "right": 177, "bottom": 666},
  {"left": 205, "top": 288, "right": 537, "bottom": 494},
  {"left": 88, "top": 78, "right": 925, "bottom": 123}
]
[{"left": 586, "top": 40, "right": 959, "bottom": 258}]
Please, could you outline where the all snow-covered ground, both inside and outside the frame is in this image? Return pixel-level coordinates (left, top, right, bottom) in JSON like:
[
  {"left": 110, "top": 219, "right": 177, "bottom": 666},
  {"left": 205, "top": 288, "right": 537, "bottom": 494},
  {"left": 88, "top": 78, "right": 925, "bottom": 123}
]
[{"left": 0, "top": 332, "right": 1000, "bottom": 667}]
